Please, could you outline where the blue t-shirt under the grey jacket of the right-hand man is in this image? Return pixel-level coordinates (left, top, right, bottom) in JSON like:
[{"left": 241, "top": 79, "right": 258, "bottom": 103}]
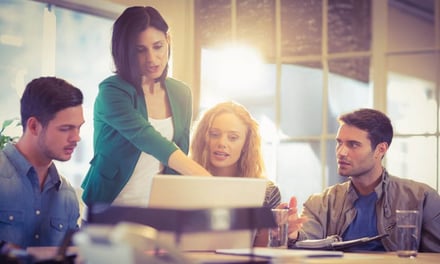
[{"left": 342, "top": 192, "right": 385, "bottom": 251}]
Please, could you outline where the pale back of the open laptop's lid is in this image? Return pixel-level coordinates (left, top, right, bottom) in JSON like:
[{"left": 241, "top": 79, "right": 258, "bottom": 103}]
[{"left": 149, "top": 175, "right": 267, "bottom": 209}]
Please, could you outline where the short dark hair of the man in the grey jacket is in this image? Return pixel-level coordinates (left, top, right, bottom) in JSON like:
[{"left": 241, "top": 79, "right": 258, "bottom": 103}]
[{"left": 339, "top": 108, "right": 393, "bottom": 149}]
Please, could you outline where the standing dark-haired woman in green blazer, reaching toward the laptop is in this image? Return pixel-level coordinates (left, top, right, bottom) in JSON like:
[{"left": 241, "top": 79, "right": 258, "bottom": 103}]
[{"left": 82, "top": 6, "right": 210, "bottom": 209}]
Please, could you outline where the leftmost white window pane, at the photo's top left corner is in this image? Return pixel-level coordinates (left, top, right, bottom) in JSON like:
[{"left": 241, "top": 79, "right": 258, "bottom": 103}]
[{"left": 0, "top": 1, "right": 45, "bottom": 122}]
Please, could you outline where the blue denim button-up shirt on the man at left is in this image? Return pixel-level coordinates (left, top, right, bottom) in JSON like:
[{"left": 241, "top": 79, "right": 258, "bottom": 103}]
[{"left": 0, "top": 144, "right": 79, "bottom": 248}]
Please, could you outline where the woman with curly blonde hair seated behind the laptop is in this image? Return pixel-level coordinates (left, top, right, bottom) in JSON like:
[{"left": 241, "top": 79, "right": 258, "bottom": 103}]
[{"left": 190, "top": 102, "right": 281, "bottom": 246}]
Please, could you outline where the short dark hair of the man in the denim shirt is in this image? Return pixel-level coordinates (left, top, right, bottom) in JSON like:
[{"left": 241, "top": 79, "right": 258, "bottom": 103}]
[{"left": 20, "top": 77, "right": 83, "bottom": 131}]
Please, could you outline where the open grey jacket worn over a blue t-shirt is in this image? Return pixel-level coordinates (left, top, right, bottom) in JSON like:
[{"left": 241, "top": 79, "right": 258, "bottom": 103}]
[{"left": 298, "top": 170, "right": 440, "bottom": 252}]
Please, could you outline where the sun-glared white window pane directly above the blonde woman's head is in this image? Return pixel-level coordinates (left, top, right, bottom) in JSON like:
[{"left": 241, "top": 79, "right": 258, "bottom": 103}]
[{"left": 200, "top": 45, "right": 276, "bottom": 112}]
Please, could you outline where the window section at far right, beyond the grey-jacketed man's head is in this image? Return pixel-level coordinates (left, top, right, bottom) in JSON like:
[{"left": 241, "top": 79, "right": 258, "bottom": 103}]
[{"left": 386, "top": 1, "right": 440, "bottom": 190}]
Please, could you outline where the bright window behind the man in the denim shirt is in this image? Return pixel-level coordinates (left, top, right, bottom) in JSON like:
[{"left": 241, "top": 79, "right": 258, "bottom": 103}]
[{"left": 0, "top": 0, "right": 113, "bottom": 187}]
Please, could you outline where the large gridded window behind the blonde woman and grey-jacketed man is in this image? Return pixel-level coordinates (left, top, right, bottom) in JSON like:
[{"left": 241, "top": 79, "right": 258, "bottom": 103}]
[{"left": 195, "top": 0, "right": 440, "bottom": 203}]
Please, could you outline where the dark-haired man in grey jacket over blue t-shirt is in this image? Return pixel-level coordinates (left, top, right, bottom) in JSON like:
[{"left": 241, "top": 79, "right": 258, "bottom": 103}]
[{"left": 289, "top": 109, "right": 440, "bottom": 252}]
